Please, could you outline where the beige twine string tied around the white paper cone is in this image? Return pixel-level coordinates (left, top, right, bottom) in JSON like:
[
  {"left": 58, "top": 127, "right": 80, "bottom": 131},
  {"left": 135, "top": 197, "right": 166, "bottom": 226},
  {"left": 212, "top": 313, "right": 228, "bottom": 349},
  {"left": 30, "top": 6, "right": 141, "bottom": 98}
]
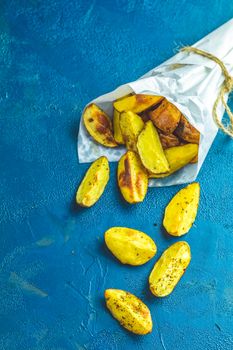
[{"left": 180, "top": 46, "right": 233, "bottom": 138}]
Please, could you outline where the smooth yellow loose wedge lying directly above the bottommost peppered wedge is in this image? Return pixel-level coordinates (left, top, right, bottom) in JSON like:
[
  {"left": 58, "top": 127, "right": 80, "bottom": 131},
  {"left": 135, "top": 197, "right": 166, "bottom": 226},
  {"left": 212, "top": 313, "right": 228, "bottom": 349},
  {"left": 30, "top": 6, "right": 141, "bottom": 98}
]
[{"left": 104, "top": 227, "right": 157, "bottom": 266}]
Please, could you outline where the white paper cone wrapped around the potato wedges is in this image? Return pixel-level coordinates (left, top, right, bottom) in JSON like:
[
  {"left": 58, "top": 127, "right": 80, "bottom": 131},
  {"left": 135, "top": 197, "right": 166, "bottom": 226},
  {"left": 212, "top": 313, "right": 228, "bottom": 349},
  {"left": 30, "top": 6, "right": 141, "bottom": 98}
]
[{"left": 78, "top": 19, "right": 233, "bottom": 186}]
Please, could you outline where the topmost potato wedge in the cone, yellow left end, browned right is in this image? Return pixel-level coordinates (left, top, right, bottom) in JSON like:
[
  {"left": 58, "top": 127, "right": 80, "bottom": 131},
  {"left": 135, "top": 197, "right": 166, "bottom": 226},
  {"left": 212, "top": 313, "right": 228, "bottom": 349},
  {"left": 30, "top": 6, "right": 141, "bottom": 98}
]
[{"left": 113, "top": 94, "right": 163, "bottom": 113}]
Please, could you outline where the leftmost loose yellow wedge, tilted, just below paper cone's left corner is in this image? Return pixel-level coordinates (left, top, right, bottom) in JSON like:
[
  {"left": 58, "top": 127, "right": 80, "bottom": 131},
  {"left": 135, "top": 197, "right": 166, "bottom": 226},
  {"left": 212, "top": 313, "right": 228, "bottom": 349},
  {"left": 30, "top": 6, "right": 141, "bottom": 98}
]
[{"left": 76, "top": 157, "right": 110, "bottom": 207}]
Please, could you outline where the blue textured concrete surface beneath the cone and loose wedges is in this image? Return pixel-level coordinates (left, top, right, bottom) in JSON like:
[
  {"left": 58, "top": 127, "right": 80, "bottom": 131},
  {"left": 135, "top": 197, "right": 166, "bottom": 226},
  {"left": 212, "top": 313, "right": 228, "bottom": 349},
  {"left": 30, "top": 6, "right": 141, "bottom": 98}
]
[{"left": 0, "top": 0, "right": 233, "bottom": 350}]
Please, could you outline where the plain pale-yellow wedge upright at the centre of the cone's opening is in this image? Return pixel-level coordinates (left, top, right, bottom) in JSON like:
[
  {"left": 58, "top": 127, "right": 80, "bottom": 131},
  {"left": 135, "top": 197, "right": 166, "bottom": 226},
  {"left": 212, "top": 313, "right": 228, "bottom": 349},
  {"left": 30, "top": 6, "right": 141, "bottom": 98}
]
[{"left": 137, "top": 120, "right": 169, "bottom": 174}]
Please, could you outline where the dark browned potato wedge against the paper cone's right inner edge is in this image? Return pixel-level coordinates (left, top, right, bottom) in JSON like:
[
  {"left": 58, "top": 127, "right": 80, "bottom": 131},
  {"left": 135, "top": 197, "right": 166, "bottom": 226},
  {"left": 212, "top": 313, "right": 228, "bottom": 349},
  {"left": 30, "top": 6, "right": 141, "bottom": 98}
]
[{"left": 174, "top": 115, "right": 200, "bottom": 144}]
